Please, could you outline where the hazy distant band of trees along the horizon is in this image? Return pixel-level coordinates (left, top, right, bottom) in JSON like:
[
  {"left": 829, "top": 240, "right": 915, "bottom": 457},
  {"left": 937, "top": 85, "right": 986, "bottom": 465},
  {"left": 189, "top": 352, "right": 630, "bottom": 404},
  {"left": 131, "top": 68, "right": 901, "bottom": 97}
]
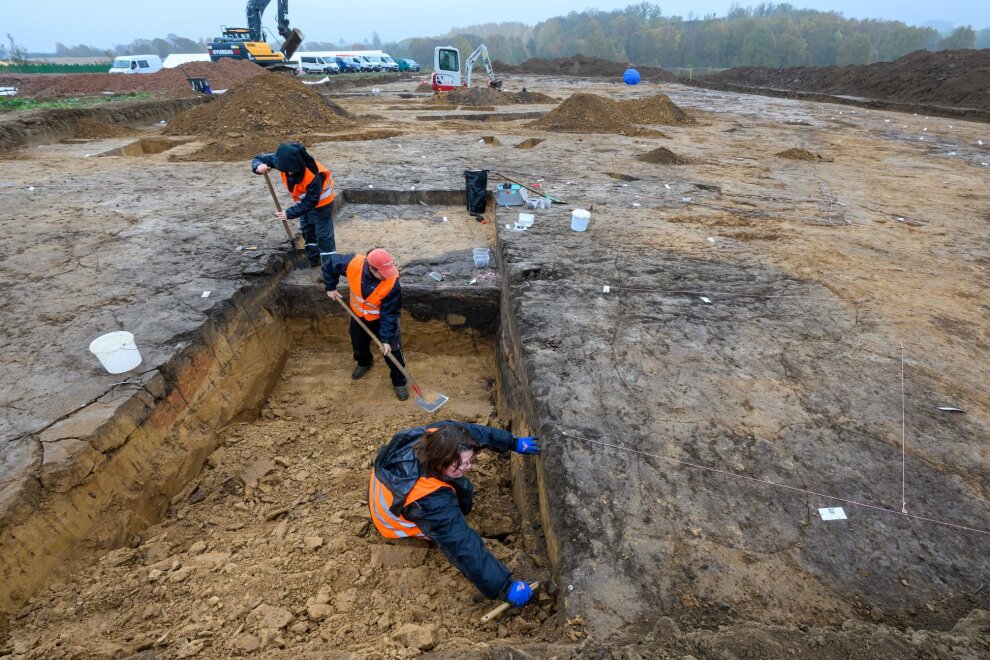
[{"left": 7, "top": 2, "right": 990, "bottom": 69}]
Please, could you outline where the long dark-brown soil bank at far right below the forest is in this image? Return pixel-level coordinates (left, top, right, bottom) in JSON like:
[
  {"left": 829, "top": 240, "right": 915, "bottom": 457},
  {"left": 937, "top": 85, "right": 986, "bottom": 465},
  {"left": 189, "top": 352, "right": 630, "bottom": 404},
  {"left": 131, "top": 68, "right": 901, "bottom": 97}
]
[{"left": 702, "top": 49, "right": 990, "bottom": 110}]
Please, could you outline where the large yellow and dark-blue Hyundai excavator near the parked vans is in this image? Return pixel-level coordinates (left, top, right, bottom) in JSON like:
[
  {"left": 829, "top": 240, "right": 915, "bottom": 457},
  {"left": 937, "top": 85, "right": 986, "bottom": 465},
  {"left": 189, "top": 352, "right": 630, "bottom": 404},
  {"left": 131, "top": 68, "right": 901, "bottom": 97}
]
[{"left": 206, "top": 0, "right": 304, "bottom": 72}]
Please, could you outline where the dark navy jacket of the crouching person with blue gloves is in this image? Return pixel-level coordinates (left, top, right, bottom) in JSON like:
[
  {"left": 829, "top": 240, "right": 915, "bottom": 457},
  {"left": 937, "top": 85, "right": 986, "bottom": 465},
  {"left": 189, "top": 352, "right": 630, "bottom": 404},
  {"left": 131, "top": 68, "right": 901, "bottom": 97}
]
[{"left": 374, "top": 420, "right": 515, "bottom": 598}]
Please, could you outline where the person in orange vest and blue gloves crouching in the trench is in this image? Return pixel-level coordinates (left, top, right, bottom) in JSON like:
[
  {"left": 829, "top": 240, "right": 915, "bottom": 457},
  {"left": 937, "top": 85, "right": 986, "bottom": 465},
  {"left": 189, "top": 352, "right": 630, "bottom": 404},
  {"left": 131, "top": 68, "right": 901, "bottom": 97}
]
[{"left": 368, "top": 420, "right": 540, "bottom": 607}]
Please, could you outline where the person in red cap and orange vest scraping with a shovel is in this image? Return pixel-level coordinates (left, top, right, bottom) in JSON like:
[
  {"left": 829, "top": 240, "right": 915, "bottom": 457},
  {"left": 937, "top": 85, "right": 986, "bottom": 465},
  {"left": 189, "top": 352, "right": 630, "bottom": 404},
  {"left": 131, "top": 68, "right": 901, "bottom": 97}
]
[{"left": 323, "top": 248, "right": 409, "bottom": 401}]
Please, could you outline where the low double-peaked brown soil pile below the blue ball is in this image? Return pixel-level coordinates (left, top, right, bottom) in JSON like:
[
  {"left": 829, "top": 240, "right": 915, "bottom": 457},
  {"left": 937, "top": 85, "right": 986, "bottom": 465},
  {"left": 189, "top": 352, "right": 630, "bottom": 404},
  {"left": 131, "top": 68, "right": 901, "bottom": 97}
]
[{"left": 531, "top": 92, "right": 691, "bottom": 137}]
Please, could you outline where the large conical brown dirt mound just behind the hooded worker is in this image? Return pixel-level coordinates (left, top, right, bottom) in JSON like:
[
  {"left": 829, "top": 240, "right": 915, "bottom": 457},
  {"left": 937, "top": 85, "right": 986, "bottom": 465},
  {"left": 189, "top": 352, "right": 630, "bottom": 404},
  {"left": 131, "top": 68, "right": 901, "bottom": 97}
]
[{"left": 165, "top": 74, "right": 356, "bottom": 142}]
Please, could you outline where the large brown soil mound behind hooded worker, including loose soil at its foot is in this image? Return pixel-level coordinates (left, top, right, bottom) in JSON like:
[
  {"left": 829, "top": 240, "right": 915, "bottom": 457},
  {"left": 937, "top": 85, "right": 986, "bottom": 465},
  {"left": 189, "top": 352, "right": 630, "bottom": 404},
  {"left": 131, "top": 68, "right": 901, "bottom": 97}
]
[{"left": 165, "top": 73, "right": 361, "bottom": 161}]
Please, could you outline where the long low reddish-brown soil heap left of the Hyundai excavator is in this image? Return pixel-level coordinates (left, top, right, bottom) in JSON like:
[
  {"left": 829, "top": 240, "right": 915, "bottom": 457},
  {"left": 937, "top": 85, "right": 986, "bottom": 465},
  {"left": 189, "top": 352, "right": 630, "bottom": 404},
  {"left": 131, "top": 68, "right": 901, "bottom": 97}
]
[{"left": 0, "top": 59, "right": 265, "bottom": 98}]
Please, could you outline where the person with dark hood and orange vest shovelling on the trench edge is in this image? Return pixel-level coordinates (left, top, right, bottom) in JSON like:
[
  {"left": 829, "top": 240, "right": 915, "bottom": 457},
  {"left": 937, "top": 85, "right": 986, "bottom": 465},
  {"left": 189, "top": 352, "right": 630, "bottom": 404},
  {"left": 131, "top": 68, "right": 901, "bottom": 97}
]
[{"left": 251, "top": 142, "right": 337, "bottom": 274}]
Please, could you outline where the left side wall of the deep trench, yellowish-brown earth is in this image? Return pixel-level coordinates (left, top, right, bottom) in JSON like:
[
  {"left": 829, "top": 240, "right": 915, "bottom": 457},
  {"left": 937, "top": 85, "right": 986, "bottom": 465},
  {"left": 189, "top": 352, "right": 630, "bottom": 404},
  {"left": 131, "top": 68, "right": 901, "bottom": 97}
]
[{"left": 0, "top": 277, "right": 289, "bottom": 627}]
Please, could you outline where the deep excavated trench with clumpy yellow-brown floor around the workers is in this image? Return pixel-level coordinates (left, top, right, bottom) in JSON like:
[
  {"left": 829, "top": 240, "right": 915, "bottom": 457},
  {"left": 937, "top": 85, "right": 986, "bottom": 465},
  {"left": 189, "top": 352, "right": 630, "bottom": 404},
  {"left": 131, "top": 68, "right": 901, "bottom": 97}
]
[{"left": 0, "top": 191, "right": 557, "bottom": 657}]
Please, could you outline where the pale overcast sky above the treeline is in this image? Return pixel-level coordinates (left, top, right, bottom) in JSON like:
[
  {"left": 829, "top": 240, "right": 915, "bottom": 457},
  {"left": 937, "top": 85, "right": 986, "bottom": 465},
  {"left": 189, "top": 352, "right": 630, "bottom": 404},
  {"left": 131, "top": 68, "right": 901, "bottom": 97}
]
[{"left": 7, "top": 0, "right": 990, "bottom": 52}]
